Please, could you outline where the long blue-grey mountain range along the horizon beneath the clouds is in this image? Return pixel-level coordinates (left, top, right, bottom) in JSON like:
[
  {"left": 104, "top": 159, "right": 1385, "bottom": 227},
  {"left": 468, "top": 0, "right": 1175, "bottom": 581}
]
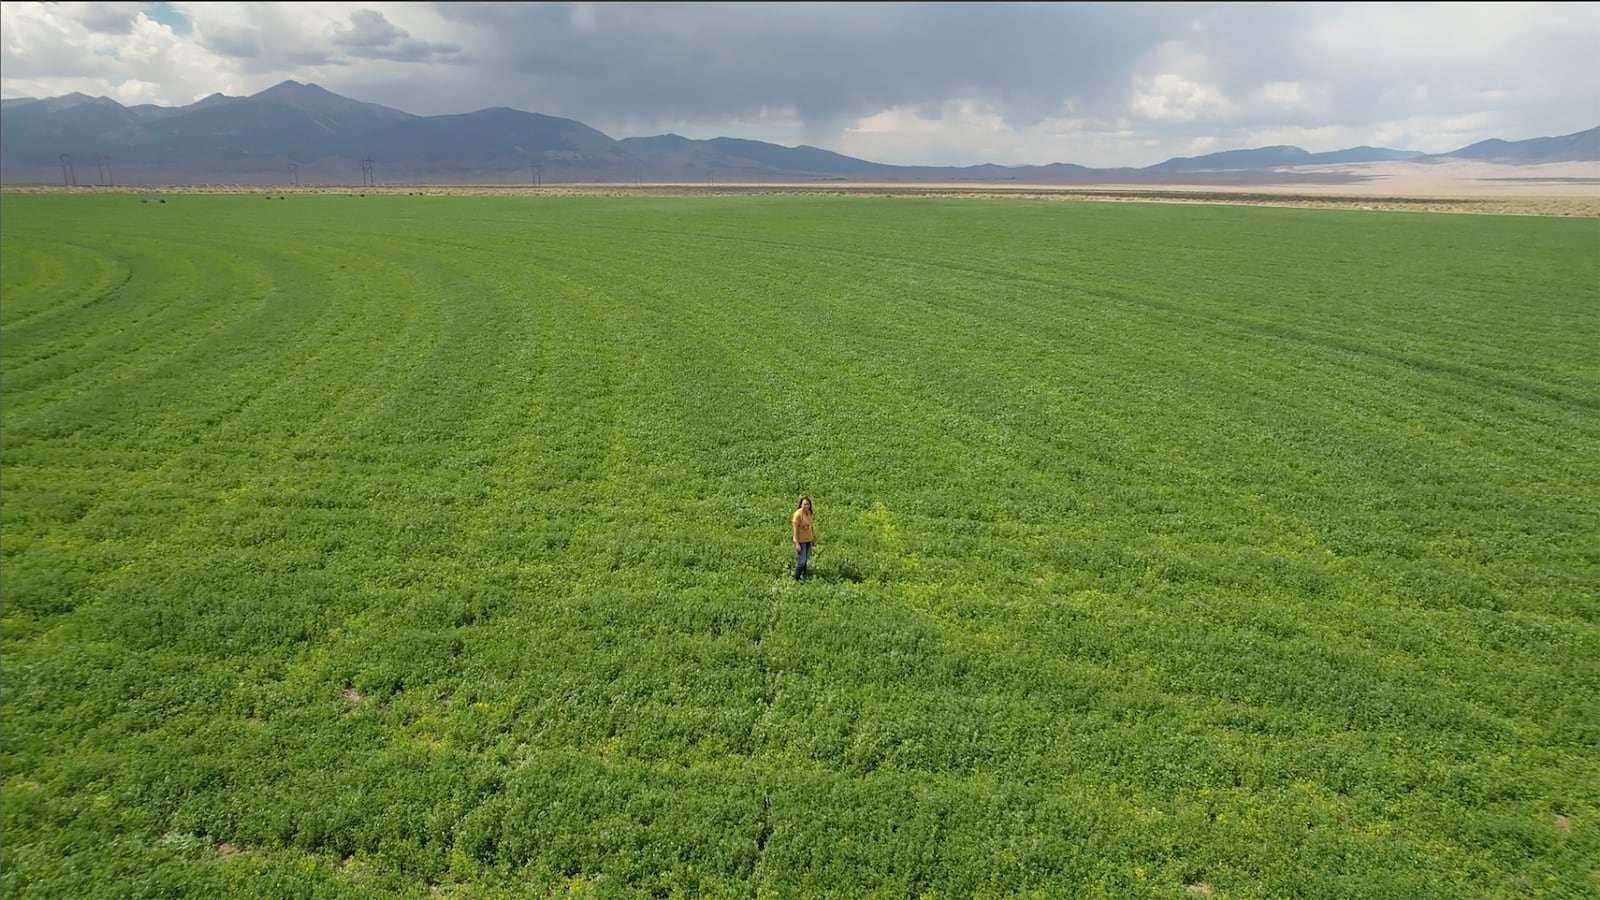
[{"left": 0, "top": 80, "right": 1600, "bottom": 186}]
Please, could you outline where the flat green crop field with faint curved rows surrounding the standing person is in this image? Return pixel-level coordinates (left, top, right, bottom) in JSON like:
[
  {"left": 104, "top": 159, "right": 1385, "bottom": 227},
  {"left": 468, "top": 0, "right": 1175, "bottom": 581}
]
[{"left": 0, "top": 187, "right": 1600, "bottom": 900}]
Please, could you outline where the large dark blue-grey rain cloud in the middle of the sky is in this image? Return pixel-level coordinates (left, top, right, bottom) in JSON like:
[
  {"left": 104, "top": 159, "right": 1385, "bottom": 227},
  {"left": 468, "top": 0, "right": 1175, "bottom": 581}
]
[{"left": 440, "top": 3, "right": 1182, "bottom": 127}]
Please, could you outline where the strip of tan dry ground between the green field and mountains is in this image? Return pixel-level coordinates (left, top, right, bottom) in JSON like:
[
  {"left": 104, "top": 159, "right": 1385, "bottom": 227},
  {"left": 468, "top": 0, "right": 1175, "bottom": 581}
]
[{"left": 5, "top": 160, "right": 1600, "bottom": 218}]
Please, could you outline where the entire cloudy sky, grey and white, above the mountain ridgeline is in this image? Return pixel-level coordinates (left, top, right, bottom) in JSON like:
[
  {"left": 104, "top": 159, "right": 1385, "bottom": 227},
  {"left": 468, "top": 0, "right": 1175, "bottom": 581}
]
[{"left": 0, "top": 2, "right": 1600, "bottom": 167}]
